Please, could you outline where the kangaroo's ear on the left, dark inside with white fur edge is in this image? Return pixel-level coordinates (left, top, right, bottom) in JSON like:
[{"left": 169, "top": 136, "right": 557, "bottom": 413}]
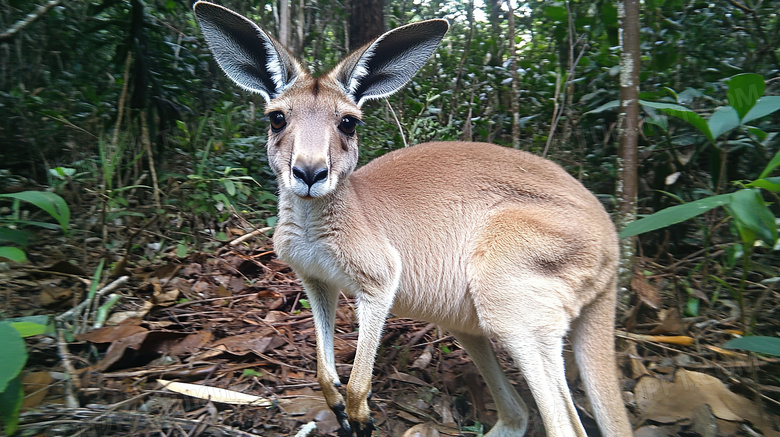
[{"left": 193, "top": 1, "right": 305, "bottom": 102}]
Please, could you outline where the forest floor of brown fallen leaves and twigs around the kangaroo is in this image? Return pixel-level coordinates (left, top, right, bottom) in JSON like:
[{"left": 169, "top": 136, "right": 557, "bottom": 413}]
[{"left": 0, "top": 209, "right": 780, "bottom": 437}]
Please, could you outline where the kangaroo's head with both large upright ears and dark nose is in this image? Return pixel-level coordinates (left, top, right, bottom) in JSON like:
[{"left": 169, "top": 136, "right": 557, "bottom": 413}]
[{"left": 194, "top": 1, "right": 449, "bottom": 198}]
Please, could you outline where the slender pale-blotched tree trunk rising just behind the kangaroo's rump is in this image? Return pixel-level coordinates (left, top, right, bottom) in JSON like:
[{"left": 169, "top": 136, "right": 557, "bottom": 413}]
[{"left": 617, "top": 0, "right": 641, "bottom": 302}]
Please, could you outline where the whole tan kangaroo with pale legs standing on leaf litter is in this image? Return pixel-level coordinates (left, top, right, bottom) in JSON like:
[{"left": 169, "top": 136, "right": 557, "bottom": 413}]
[{"left": 194, "top": 1, "right": 632, "bottom": 437}]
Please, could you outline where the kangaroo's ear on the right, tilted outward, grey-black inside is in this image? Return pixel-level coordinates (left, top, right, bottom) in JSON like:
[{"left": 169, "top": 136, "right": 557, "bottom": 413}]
[{"left": 330, "top": 20, "right": 450, "bottom": 106}]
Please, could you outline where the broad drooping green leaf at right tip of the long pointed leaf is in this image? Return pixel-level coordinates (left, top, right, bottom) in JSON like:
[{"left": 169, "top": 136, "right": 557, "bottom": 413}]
[{"left": 728, "top": 189, "right": 777, "bottom": 247}]
